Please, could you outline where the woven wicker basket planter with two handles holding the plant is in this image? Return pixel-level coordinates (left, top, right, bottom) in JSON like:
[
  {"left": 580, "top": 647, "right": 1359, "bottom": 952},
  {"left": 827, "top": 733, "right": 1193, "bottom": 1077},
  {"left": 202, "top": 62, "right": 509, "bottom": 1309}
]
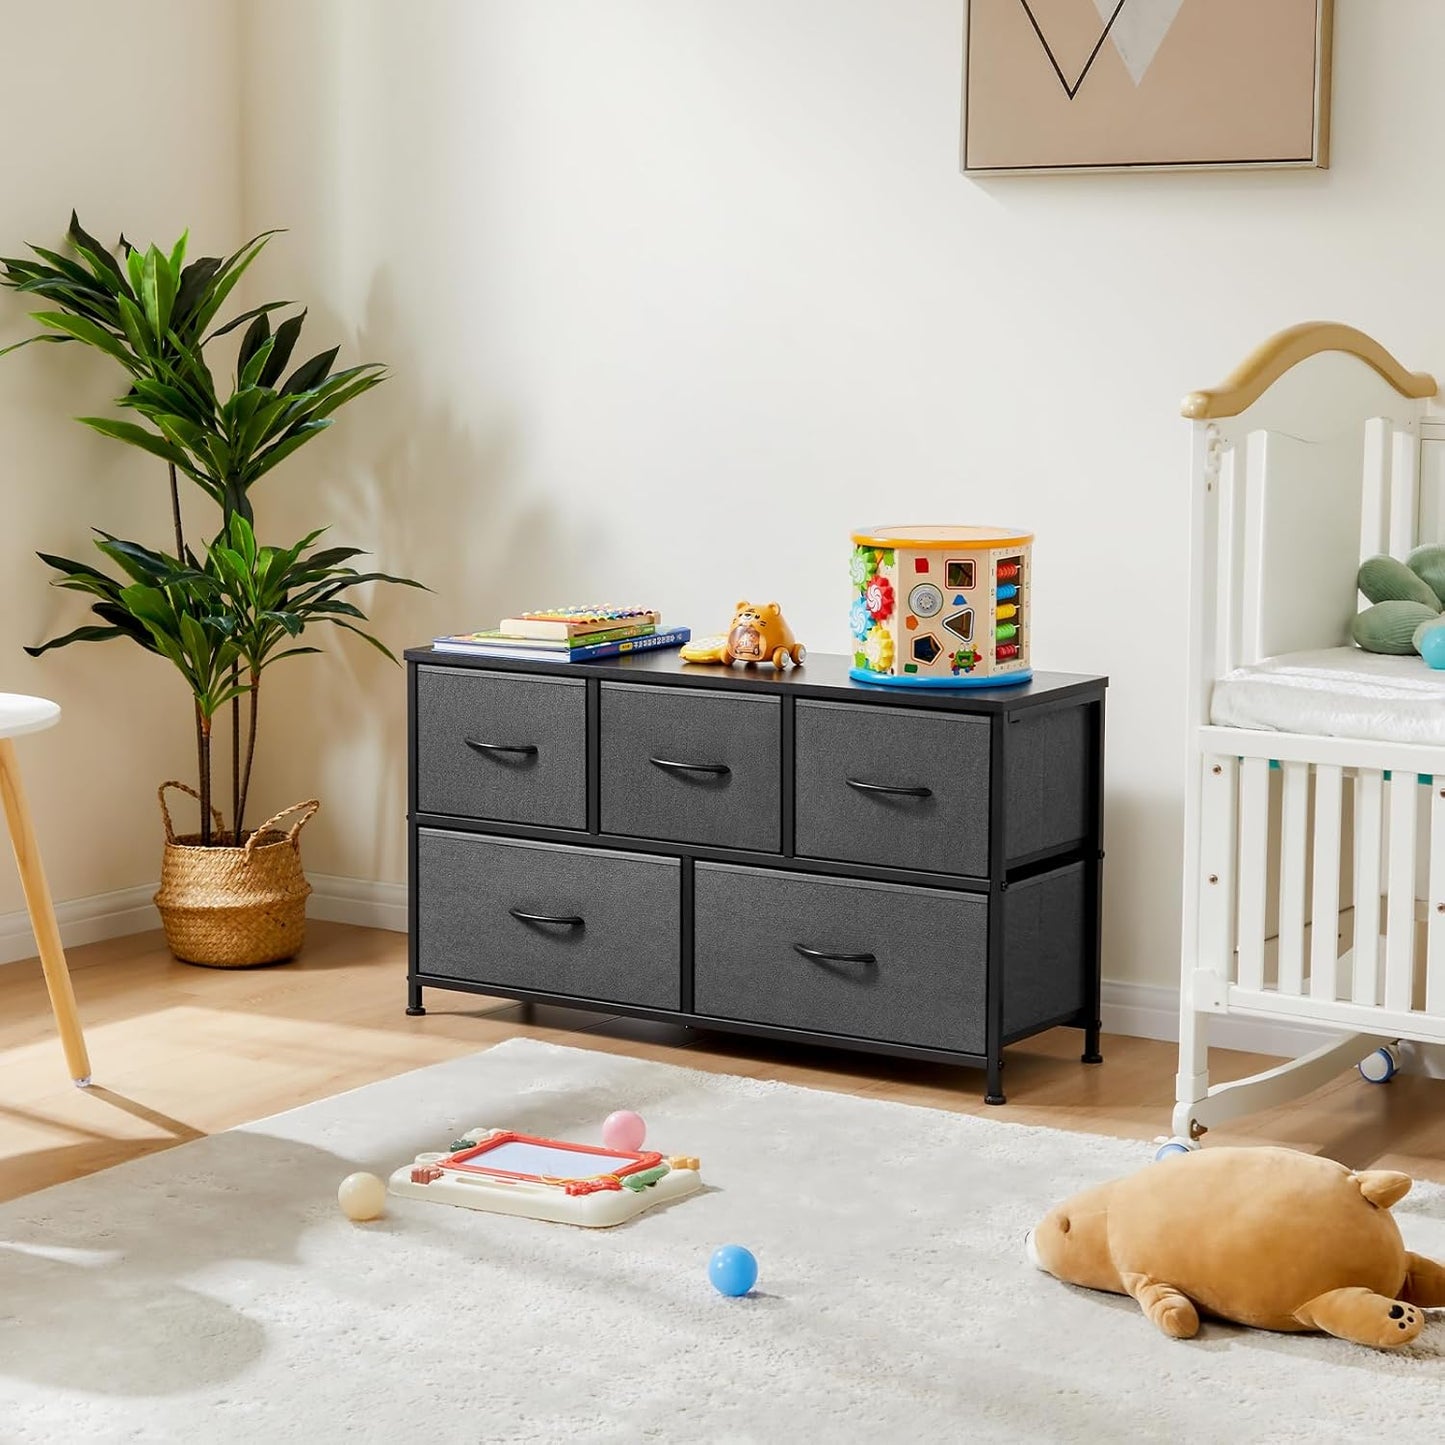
[{"left": 155, "top": 782, "right": 321, "bottom": 968}]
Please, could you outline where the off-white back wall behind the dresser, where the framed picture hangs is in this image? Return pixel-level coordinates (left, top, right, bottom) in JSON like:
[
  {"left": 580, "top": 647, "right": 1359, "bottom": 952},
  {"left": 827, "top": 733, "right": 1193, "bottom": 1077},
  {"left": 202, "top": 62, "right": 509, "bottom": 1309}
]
[{"left": 14, "top": 0, "right": 1445, "bottom": 984}]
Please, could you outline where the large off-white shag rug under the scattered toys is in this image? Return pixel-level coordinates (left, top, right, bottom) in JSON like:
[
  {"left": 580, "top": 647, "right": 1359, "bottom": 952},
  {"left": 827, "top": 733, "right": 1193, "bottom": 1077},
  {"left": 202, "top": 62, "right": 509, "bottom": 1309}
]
[{"left": 0, "top": 1039, "right": 1445, "bottom": 1445}]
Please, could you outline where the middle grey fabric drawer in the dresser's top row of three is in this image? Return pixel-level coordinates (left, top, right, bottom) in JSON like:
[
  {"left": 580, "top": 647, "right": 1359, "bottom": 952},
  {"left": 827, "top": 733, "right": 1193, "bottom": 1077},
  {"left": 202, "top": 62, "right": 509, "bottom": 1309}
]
[{"left": 601, "top": 682, "right": 782, "bottom": 853}]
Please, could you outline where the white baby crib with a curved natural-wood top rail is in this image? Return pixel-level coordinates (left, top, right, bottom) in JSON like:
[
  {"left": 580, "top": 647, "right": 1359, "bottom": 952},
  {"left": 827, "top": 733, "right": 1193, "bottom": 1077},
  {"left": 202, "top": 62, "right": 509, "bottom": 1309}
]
[{"left": 1166, "top": 322, "right": 1445, "bottom": 1149}]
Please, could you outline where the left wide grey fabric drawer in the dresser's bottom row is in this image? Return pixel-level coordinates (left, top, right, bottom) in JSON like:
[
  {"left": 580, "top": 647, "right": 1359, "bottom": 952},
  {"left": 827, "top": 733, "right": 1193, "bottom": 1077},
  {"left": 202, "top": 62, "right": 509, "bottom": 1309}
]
[{"left": 416, "top": 828, "right": 682, "bottom": 1009}]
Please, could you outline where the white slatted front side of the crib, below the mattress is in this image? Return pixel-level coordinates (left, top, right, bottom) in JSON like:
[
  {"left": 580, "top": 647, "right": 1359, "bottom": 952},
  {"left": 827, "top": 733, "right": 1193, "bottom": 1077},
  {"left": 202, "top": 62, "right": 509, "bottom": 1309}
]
[{"left": 1192, "top": 728, "right": 1445, "bottom": 1040}]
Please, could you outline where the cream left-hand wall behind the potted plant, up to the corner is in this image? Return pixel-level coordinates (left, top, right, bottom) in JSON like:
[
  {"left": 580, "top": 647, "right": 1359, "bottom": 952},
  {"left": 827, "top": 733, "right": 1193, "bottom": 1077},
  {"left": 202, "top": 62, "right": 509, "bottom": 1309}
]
[{"left": 0, "top": 0, "right": 240, "bottom": 915}]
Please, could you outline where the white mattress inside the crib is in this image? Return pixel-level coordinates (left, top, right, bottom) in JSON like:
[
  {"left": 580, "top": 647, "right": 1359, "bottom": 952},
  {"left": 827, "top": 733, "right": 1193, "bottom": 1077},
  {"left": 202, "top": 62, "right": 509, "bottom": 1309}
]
[{"left": 1209, "top": 647, "right": 1445, "bottom": 747}]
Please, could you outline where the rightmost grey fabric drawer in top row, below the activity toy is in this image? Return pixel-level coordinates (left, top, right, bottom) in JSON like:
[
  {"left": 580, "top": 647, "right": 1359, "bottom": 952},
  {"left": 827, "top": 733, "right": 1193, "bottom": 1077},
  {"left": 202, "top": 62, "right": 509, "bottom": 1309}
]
[{"left": 796, "top": 701, "right": 990, "bottom": 877}]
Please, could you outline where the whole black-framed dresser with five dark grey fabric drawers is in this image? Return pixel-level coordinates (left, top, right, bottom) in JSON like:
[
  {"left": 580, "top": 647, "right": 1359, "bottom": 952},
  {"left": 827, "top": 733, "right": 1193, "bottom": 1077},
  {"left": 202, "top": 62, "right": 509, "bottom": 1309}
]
[{"left": 406, "top": 649, "right": 1105, "bottom": 1104}]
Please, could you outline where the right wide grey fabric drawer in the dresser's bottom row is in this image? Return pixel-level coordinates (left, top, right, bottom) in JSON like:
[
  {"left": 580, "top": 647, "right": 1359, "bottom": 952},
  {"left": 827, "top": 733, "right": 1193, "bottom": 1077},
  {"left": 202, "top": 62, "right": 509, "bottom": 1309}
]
[{"left": 694, "top": 863, "right": 988, "bottom": 1053}]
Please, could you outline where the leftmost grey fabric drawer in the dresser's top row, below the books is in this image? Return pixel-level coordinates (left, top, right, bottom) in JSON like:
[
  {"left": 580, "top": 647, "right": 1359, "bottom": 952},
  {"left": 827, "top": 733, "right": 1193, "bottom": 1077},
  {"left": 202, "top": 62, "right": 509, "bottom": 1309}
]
[{"left": 416, "top": 666, "right": 587, "bottom": 828}]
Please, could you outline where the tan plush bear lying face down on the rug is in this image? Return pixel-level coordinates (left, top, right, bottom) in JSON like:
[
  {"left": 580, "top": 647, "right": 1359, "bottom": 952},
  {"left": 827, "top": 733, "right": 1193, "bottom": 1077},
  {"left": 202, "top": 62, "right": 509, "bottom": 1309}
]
[{"left": 1027, "top": 1147, "right": 1445, "bottom": 1350}]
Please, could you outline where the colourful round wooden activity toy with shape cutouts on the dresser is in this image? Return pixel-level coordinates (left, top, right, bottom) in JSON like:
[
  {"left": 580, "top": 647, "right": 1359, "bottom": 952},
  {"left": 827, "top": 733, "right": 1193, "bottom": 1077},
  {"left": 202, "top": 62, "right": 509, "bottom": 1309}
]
[{"left": 850, "top": 526, "right": 1033, "bottom": 688}]
